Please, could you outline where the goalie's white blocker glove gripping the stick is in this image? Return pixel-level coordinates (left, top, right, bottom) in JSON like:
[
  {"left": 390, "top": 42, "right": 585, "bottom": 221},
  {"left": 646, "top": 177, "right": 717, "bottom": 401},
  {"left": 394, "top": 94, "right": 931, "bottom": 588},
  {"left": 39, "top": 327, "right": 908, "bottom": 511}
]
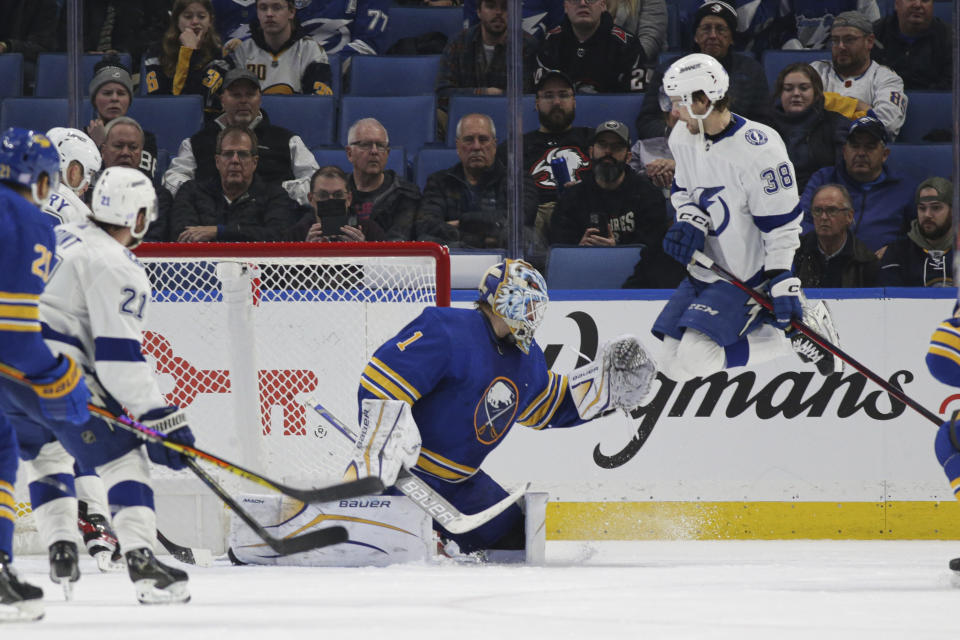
[{"left": 344, "top": 399, "right": 420, "bottom": 487}]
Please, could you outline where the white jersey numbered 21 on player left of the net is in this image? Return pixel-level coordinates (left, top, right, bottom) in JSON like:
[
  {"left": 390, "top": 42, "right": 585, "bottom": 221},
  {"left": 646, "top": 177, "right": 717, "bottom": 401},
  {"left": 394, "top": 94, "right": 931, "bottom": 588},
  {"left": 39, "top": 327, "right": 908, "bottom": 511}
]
[{"left": 40, "top": 222, "right": 168, "bottom": 418}]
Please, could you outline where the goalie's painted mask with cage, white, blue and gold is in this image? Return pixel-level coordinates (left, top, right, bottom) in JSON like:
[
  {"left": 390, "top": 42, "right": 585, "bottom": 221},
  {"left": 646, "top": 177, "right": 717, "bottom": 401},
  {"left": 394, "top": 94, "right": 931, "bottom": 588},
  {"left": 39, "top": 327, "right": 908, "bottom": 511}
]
[{"left": 479, "top": 260, "right": 549, "bottom": 353}]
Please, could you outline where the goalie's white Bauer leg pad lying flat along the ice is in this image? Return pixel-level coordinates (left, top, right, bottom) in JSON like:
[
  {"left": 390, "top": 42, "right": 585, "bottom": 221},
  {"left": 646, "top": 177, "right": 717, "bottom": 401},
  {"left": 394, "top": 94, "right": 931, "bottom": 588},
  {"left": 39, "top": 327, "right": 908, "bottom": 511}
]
[{"left": 228, "top": 494, "right": 435, "bottom": 567}]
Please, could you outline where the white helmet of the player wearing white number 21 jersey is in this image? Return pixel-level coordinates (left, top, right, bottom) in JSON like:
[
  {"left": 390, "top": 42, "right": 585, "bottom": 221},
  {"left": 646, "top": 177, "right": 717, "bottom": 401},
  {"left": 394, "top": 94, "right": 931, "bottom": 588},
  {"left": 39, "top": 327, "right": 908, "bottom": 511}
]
[{"left": 90, "top": 167, "right": 157, "bottom": 244}]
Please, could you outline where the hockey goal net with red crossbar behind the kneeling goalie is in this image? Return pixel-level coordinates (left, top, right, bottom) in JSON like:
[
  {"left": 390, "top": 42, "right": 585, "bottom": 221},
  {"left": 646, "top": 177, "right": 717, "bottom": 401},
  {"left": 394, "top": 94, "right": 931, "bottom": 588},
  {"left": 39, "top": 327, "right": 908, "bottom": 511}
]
[{"left": 17, "top": 242, "right": 450, "bottom": 542}]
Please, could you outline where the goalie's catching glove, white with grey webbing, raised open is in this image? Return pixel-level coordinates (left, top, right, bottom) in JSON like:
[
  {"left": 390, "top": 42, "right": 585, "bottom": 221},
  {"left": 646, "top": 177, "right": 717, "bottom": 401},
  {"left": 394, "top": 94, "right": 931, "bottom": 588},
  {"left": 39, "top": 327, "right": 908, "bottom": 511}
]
[{"left": 567, "top": 335, "right": 657, "bottom": 420}]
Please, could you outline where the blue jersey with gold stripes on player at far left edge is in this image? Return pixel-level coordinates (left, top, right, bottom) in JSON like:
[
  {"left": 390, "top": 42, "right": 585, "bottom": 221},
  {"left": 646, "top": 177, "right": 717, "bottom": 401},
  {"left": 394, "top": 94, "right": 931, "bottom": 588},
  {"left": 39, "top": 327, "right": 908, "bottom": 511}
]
[{"left": 0, "top": 184, "right": 57, "bottom": 376}]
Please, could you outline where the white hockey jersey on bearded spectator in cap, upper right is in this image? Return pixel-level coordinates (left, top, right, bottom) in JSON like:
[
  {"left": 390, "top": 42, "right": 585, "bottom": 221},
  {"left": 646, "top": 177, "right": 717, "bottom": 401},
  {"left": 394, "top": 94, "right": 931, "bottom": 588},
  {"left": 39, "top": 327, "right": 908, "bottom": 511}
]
[{"left": 810, "top": 60, "right": 907, "bottom": 138}]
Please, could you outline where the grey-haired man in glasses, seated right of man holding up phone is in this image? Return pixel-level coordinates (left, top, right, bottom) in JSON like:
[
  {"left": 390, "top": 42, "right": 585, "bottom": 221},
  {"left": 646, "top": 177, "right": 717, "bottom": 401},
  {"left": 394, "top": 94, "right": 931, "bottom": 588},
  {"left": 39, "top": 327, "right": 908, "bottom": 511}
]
[{"left": 346, "top": 118, "right": 420, "bottom": 241}]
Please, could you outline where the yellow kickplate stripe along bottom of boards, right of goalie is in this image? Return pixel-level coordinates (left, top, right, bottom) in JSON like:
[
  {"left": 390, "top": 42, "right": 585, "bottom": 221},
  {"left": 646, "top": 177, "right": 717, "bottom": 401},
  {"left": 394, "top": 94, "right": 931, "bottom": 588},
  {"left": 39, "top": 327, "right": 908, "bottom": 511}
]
[{"left": 547, "top": 501, "right": 960, "bottom": 540}]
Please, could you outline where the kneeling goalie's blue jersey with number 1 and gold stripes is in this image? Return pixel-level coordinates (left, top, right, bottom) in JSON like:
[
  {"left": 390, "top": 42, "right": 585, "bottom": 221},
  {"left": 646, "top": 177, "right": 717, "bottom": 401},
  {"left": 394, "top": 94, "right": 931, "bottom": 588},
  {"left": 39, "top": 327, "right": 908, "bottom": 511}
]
[{"left": 358, "top": 307, "right": 583, "bottom": 482}]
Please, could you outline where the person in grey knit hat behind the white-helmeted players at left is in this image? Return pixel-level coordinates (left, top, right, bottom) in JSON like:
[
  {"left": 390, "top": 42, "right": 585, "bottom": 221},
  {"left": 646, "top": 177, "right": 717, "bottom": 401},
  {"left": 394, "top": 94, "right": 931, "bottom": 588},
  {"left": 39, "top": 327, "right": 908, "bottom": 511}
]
[{"left": 86, "top": 56, "right": 157, "bottom": 178}]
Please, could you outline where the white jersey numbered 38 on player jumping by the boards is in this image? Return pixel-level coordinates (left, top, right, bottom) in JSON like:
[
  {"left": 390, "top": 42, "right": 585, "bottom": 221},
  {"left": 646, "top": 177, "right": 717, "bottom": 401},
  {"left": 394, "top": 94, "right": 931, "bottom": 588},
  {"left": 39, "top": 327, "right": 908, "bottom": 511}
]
[{"left": 668, "top": 112, "right": 800, "bottom": 283}]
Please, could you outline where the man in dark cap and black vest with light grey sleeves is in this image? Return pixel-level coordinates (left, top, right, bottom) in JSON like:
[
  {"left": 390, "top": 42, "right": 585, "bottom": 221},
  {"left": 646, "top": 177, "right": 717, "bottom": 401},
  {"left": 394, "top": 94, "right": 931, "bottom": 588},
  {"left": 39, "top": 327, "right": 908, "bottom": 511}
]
[{"left": 163, "top": 69, "right": 319, "bottom": 202}]
